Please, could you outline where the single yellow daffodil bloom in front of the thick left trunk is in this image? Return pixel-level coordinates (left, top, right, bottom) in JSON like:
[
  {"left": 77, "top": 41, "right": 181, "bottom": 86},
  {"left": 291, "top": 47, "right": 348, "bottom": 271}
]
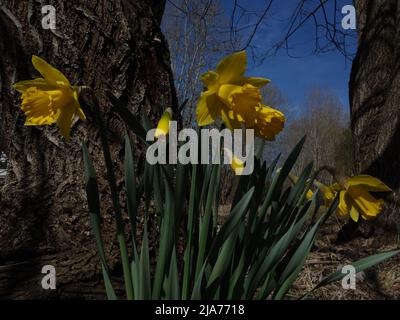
[{"left": 14, "top": 56, "right": 86, "bottom": 140}]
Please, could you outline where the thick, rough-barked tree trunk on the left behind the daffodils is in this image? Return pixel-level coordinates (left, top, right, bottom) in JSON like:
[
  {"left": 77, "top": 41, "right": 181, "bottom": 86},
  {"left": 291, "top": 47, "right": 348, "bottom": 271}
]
[{"left": 0, "top": 0, "right": 177, "bottom": 299}]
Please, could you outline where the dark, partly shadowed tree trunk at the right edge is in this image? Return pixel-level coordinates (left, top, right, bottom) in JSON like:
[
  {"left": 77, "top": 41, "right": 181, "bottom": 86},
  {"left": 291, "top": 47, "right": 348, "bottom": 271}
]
[{"left": 349, "top": 0, "right": 400, "bottom": 229}]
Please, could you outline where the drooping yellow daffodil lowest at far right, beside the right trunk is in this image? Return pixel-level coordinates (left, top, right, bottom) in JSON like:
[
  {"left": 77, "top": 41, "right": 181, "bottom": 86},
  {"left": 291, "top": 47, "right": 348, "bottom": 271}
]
[{"left": 332, "top": 175, "right": 391, "bottom": 222}]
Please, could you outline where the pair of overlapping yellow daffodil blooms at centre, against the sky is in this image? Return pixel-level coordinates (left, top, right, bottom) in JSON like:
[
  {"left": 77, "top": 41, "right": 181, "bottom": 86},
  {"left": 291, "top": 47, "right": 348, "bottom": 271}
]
[{"left": 196, "top": 51, "right": 285, "bottom": 140}]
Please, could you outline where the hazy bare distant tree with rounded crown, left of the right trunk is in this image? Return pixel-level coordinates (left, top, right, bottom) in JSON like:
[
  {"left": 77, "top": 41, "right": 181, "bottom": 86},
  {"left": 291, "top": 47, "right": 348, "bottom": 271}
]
[{"left": 280, "top": 88, "right": 352, "bottom": 183}]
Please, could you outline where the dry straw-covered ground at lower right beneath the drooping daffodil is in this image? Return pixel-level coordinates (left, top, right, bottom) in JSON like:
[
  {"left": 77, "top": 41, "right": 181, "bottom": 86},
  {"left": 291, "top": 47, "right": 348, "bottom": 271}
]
[{"left": 287, "top": 217, "right": 400, "bottom": 300}]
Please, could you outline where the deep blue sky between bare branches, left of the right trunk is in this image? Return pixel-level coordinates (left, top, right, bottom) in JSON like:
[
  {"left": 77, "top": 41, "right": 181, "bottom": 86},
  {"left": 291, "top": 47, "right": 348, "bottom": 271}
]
[{"left": 222, "top": 0, "right": 355, "bottom": 111}]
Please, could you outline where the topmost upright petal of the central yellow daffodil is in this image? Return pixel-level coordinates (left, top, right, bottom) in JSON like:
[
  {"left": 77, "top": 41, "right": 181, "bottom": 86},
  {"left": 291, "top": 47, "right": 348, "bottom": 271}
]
[{"left": 217, "top": 51, "right": 247, "bottom": 83}]
